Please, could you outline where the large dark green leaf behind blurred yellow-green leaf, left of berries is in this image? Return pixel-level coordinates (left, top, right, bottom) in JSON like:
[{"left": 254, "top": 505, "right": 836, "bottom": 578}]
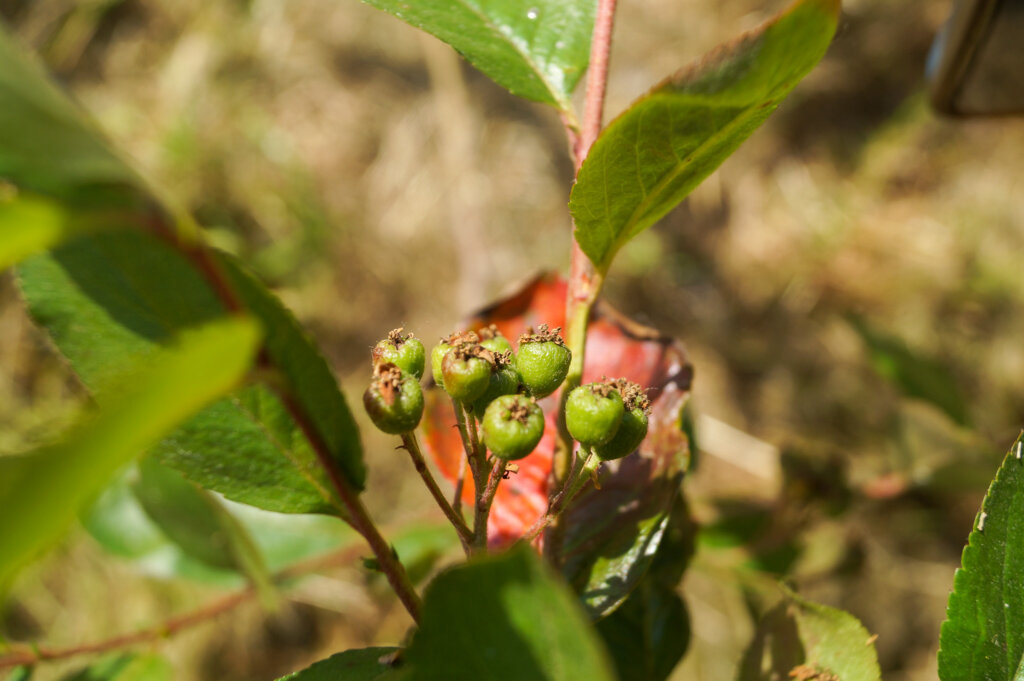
[{"left": 18, "top": 231, "right": 361, "bottom": 515}]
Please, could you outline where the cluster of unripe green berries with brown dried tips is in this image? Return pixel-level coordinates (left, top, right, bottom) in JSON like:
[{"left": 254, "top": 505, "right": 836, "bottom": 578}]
[{"left": 364, "top": 325, "right": 648, "bottom": 461}]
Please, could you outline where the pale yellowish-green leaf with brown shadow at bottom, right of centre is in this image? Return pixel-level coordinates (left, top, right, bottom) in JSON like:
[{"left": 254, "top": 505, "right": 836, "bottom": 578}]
[{"left": 738, "top": 589, "right": 882, "bottom": 681}]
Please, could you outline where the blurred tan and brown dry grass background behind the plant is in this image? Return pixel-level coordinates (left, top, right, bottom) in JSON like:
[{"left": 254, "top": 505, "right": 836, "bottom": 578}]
[{"left": 0, "top": 0, "right": 1024, "bottom": 681}]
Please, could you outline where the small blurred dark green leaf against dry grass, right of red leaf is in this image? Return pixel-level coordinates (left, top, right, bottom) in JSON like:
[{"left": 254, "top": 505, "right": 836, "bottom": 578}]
[{"left": 851, "top": 317, "right": 968, "bottom": 425}]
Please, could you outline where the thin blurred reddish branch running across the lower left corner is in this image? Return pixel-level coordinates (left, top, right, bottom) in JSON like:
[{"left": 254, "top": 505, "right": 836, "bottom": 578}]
[{"left": 0, "top": 546, "right": 362, "bottom": 670}]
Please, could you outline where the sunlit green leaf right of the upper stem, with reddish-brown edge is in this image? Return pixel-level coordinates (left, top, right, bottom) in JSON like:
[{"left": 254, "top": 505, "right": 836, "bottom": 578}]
[{"left": 569, "top": 0, "right": 840, "bottom": 272}]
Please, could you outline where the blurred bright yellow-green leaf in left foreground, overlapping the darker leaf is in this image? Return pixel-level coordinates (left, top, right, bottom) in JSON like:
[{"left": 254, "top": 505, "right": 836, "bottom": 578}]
[{"left": 0, "top": 318, "right": 259, "bottom": 583}]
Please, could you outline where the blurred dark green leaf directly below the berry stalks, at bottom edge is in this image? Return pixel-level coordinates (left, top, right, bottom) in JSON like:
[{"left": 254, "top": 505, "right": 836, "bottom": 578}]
[{"left": 406, "top": 547, "right": 613, "bottom": 681}]
